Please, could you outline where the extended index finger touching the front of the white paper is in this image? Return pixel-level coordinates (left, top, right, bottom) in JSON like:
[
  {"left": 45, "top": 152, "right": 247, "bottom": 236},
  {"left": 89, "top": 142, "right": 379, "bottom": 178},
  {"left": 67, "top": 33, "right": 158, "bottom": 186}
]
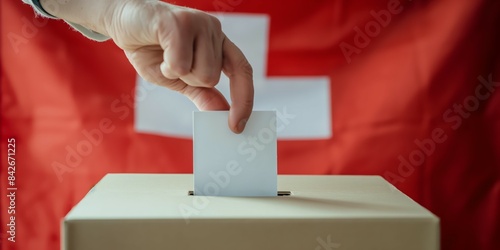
[{"left": 222, "top": 37, "right": 254, "bottom": 133}]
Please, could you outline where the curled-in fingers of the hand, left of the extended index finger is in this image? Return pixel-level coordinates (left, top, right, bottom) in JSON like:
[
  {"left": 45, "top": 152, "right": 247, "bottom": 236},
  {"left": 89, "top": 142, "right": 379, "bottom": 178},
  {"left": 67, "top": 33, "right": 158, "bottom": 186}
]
[{"left": 161, "top": 11, "right": 223, "bottom": 88}]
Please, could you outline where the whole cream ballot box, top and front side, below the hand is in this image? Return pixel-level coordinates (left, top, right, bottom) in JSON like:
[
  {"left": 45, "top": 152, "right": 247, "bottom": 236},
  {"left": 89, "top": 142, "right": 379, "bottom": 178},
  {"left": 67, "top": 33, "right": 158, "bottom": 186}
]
[{"left": 62, "top": 174, "right": 439, "bottom": 250}]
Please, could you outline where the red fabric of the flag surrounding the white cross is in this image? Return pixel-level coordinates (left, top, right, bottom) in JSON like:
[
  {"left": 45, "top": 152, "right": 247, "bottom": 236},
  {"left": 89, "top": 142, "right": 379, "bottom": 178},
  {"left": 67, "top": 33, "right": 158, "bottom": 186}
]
[{"left": 1, "top": 0, "right": 500, "bottom": 250}]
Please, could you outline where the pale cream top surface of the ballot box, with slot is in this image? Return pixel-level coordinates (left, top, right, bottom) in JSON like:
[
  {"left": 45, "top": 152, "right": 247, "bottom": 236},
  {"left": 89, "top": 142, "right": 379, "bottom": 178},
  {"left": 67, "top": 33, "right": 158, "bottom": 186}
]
[{"left": 66, "top": 174, "right": 437, "bottom": 220}]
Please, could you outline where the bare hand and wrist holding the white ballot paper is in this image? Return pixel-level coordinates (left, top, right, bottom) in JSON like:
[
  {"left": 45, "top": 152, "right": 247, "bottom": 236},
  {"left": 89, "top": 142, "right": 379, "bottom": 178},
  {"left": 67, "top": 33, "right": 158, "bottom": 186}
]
[{"left": 40, "top": 0, "right": 254, "bottom": 133}]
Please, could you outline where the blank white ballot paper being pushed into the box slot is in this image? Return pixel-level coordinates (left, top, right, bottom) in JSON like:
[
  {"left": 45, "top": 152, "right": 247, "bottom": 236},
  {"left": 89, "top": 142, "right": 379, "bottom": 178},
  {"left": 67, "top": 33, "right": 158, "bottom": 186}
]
[{"left": 193, "top": 111, "right": 277, "bottom": 196}]
